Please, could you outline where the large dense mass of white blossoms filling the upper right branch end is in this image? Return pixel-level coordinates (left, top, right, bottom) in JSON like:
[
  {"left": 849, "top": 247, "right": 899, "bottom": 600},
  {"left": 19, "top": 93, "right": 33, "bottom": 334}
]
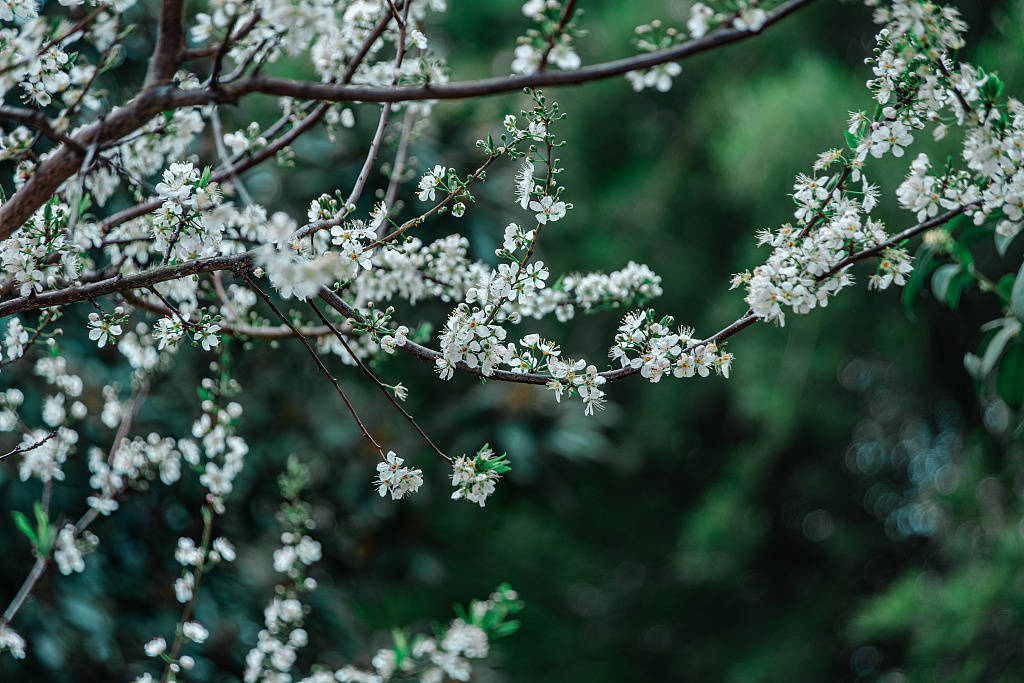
[{"left": 733, "top": 0, "right": 1024, "bottom": 331}]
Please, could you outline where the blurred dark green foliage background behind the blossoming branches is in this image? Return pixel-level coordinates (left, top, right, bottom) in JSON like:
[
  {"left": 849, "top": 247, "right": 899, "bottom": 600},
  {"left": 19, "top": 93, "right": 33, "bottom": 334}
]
[{"left": 0, "top": 0, "right": 1024, "bottom": 683}]
